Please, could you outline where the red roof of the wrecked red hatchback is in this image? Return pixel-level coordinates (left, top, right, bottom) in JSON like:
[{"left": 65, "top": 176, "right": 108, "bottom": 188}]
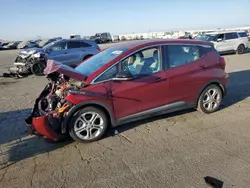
[{"left": 110, "top": 39, "right": 212, "bottom": 49}]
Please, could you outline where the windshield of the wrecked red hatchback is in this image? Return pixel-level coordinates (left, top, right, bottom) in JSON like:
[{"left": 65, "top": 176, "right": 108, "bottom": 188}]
[{"left": 75, "top": 47, "right": 128, "bottom": 76}]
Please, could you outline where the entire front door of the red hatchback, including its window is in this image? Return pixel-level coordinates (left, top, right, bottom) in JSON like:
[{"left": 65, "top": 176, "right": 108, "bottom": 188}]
[{"left": 112, "top": 47, "right": 168, "bottom": 119}]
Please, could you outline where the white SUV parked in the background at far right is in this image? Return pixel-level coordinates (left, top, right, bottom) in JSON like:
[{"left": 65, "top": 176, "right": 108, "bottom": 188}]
[{"left": 197, "top": 31, "right": 249, "bottom": 54}]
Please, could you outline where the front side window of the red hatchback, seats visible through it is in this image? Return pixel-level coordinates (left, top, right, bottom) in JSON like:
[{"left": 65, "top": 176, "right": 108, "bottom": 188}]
[{"left": 121, "top": 47, "right": 161, "bottom": 76}]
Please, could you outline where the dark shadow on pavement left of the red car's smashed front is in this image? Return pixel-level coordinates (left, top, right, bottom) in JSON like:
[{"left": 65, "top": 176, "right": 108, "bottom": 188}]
[{"left": 0, "top": 109, "right": 72, "bottom": 170}]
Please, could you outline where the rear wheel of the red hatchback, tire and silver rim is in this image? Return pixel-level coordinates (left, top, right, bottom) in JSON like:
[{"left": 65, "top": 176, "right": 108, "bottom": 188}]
[{"left": 197, "top": 84, "right": 223, "bottom": 114}]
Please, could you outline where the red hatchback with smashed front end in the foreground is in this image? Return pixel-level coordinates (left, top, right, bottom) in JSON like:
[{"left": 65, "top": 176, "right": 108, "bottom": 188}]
[{"left": 26, "top": 39, "right": 228, "bottom": 142}]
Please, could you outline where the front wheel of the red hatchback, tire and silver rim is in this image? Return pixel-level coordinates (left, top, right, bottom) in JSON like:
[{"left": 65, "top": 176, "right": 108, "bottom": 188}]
[{"left": 69, "top": 107, "right": 108, "bottom": 143}]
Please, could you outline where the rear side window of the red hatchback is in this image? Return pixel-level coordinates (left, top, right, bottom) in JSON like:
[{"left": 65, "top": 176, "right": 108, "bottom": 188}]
[{"left": 167, "top": 45, "right": 200, "bottom": 68}]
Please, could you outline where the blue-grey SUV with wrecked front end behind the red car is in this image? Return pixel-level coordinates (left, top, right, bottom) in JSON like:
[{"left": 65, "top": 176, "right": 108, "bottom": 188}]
[{"left": 10, "top": 39, "right": 100, "bottom": 75}]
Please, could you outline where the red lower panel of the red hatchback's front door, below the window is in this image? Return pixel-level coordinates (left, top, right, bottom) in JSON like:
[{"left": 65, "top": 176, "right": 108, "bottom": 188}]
[{"left": 112, "top": 71, "right": 168, "bottom": 119}]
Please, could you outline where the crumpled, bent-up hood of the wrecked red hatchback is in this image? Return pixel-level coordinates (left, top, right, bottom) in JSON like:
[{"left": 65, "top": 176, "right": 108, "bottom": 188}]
[{"left": 44, "top": 60, "right": 87, "bottom": 81}]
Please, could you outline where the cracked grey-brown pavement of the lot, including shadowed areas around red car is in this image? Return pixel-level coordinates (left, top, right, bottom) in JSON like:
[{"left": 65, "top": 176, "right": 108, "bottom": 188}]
[{"left": 0, "top": 46, "right": 250, "bottom": 188}]
